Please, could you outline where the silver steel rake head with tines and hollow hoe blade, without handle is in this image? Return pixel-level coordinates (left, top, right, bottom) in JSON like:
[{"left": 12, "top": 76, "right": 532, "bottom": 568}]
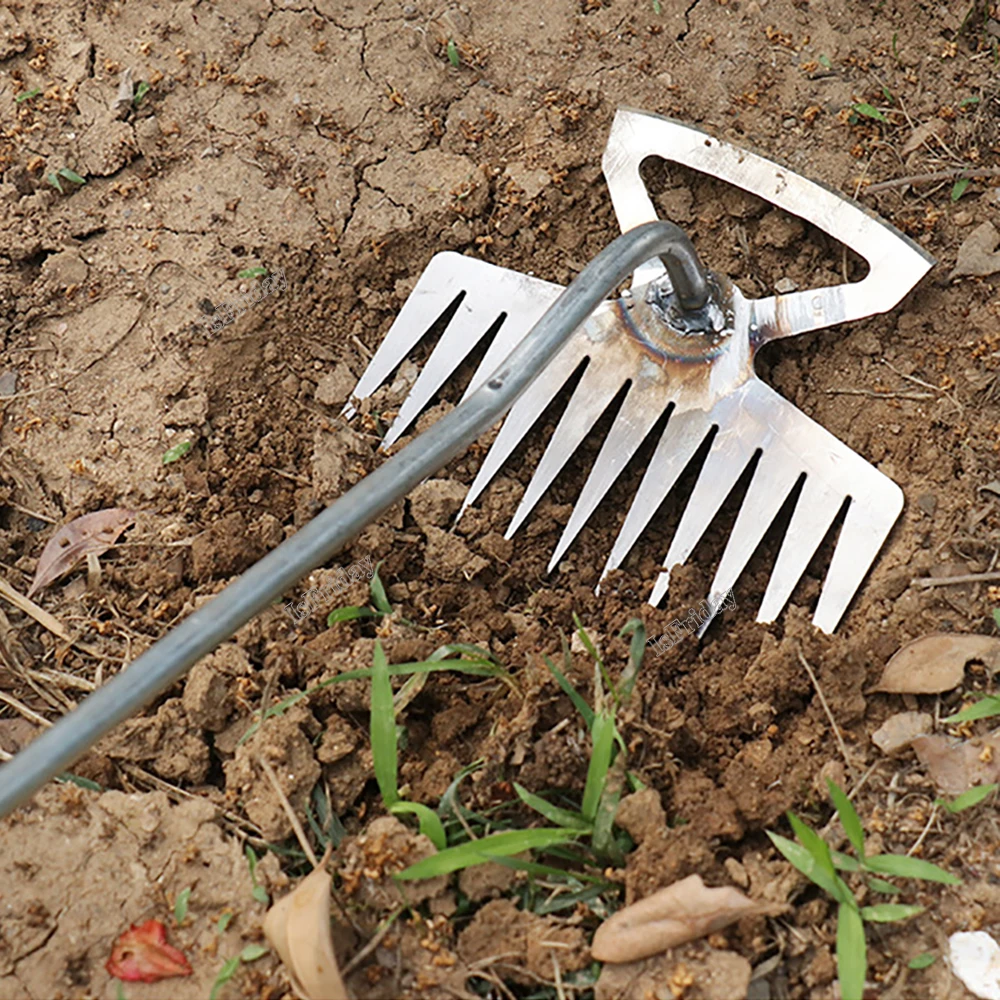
[{"left": 345, "top": 110, "right": 934, "bottom": 634}]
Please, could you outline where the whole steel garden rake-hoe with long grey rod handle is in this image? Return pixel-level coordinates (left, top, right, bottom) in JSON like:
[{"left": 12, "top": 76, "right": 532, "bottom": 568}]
[{"left": 0, "top": 111, "right": 933, "bottom": 816}]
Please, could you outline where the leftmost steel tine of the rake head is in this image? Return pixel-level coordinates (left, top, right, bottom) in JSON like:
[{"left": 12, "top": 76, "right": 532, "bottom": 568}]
[{"left": 343, "top": 252, "right": 472, "bottom": 417}]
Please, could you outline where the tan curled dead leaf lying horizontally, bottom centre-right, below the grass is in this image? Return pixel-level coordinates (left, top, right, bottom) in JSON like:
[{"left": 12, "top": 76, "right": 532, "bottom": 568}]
[{"left": 590, "top": 875, "right": 784, "bottom": 962}]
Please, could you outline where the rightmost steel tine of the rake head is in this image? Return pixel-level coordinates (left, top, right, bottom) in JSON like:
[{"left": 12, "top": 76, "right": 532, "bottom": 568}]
[{"left": 813, "top": 478, "right": 903, "bottom": 632}]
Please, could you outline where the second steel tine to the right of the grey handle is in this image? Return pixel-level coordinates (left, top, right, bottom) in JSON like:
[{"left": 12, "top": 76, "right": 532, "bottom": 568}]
[{"left": 504, "top": 348, "right": 631, "bottom": 538}]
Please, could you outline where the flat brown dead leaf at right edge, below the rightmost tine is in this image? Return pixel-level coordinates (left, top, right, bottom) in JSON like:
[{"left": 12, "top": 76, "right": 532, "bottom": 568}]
[{"left": 875, "top": 632, "right": 1000, "bottom": 694}]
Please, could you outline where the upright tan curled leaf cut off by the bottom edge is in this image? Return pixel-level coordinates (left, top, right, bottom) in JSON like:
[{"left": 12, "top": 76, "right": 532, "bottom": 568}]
[{"left": 264, "top": 858, "right": 348, "bottom": 1000}]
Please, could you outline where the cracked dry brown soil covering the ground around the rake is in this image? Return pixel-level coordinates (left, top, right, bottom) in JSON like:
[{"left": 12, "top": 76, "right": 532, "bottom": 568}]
[{"left": 0, "top": 0, "right": 1000, "bottom": 1000}]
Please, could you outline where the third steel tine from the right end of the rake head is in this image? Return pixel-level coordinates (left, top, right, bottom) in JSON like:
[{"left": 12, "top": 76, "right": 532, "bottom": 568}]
[{"left": 697, "top": 456, "right": 802, "bottom": 639}]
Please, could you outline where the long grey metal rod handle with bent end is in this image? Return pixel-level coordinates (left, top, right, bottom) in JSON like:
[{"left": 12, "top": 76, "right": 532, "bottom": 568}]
[{"left": 0, "top": 222, "right": 703, "bottom": 816}]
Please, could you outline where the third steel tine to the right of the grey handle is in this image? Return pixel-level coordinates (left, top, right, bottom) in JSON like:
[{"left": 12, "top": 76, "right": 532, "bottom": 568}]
[{"left": 548, "top": 379, "right": 671, "bottom": 572}]
